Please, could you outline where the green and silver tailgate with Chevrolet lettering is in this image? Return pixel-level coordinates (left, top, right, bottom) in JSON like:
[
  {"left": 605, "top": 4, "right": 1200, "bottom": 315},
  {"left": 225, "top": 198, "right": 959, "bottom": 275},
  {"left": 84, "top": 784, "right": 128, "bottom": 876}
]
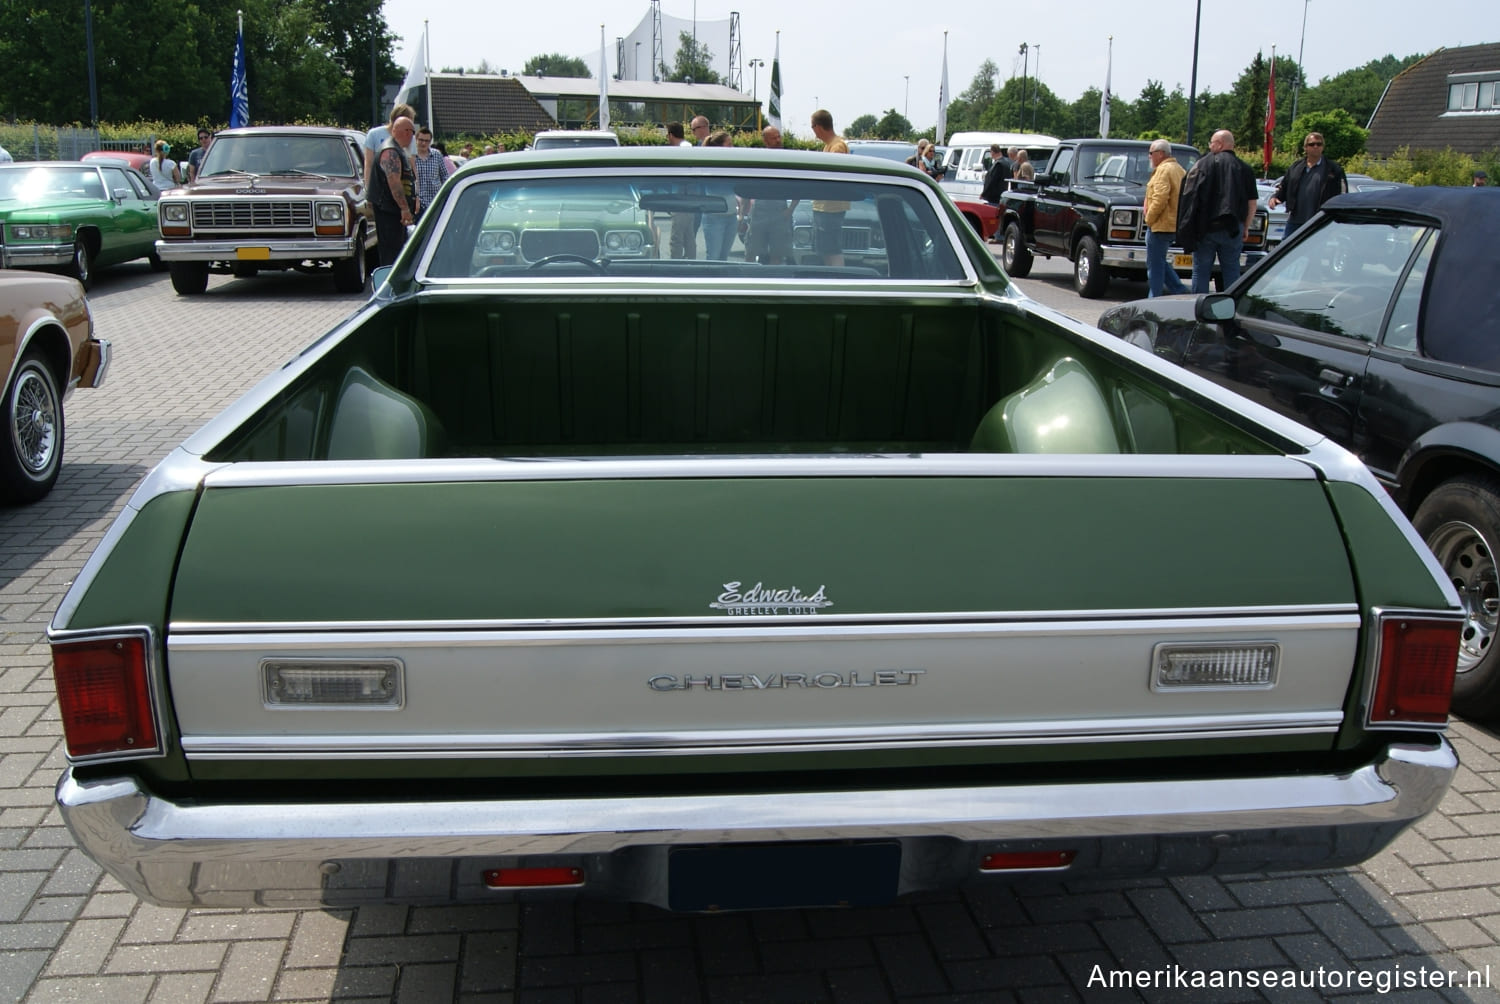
[{"left": 167, "top": 458, "right": 1359, "bottom": 771}]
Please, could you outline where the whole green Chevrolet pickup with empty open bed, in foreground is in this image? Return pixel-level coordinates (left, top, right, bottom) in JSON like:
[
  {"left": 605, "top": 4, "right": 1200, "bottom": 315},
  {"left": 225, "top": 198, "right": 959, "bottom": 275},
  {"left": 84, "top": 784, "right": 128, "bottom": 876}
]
[{"left": 50, "top": 149, "right": 1461, "bottom": 911}]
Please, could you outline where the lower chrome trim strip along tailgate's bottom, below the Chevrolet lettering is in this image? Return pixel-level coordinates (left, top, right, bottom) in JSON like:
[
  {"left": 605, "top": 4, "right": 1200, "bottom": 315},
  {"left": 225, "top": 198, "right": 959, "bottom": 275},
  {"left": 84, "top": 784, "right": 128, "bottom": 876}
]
[{"left": 182, "top": 708, "right": 1344, "bottom": 761}]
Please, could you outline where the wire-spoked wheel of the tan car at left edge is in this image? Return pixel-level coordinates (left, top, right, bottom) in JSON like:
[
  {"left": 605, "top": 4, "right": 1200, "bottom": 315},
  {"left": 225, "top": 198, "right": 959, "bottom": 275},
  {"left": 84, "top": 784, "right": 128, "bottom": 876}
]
[{"left": 0, "top": 351, "right": 63, "bottom": 503}]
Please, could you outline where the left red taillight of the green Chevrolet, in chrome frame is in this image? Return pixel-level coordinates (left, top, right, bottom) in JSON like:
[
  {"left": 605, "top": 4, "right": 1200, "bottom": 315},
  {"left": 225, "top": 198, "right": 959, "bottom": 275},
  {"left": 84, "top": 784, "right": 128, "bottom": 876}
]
[{"left": 53, "top": 635, "right": 156, "bottom": 756}]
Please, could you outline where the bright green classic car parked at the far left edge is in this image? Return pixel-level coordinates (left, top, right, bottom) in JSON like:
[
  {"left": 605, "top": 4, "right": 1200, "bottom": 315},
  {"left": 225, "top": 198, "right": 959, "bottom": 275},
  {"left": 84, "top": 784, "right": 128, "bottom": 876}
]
[{"left": 0, "top": 161, "right": 165, "bottom": 290}]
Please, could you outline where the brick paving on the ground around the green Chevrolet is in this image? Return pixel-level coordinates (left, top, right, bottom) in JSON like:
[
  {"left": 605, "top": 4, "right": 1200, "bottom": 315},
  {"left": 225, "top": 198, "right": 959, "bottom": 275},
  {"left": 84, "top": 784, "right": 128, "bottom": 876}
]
[{"left": 0, "top": 266, "right": 1500, "bottom": 1004}]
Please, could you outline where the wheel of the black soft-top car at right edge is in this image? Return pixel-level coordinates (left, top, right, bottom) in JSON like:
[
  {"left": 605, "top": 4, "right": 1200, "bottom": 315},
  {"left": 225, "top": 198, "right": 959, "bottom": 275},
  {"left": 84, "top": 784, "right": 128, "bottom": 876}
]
[{"left": 1412, "top": 476, "right": 1500, "bottom": 719}]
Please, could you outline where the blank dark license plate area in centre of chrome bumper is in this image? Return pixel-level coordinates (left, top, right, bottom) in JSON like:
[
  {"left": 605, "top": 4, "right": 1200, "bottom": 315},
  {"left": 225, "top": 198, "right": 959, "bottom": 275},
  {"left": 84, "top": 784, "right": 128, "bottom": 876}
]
[{"left": 668, "top": 842, "right": 902, "bottom": 911}]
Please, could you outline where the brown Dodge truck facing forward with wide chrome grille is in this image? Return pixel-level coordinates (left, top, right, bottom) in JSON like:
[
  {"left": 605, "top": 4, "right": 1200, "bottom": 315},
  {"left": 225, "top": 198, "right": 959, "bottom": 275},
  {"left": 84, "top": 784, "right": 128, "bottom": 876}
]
[{"left": 156, "top": 126, "right": 380, "bottom": 296}]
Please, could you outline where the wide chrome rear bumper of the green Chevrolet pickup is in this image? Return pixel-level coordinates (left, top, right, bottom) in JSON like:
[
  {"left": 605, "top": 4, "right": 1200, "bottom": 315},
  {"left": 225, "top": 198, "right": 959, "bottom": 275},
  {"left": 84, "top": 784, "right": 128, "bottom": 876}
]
[{"left": 57, "top": 738, "right": 1458, "bottom": 906}]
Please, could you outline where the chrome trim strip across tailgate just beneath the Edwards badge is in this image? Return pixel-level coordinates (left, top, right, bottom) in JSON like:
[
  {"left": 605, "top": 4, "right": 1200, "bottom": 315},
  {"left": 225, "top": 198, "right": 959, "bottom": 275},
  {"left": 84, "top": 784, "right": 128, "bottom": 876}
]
[{"left": 168, "top": 603, "right": 1361, "bottom": 633}]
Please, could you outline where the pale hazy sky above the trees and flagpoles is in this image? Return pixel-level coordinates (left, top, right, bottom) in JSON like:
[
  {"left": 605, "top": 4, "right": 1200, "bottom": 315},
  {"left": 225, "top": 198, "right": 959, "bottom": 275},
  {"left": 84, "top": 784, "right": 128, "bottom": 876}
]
[{"left": 384, "top": 0, "right": 1500, "bottom": 134}]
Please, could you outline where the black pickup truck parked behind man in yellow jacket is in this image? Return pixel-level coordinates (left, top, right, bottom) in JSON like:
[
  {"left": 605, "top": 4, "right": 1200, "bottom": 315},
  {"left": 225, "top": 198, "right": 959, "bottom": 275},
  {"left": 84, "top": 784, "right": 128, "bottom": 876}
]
[{"left": 1001, "top": 140, "right": 1266, "bottom": 297}]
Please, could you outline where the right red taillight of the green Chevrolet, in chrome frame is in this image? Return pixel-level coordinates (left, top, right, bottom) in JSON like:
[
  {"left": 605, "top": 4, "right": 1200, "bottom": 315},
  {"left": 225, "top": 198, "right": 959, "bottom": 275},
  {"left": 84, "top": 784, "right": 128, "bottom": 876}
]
[{"left": 1370, "top": 614, "right": 1463, "bottom": 725}]
